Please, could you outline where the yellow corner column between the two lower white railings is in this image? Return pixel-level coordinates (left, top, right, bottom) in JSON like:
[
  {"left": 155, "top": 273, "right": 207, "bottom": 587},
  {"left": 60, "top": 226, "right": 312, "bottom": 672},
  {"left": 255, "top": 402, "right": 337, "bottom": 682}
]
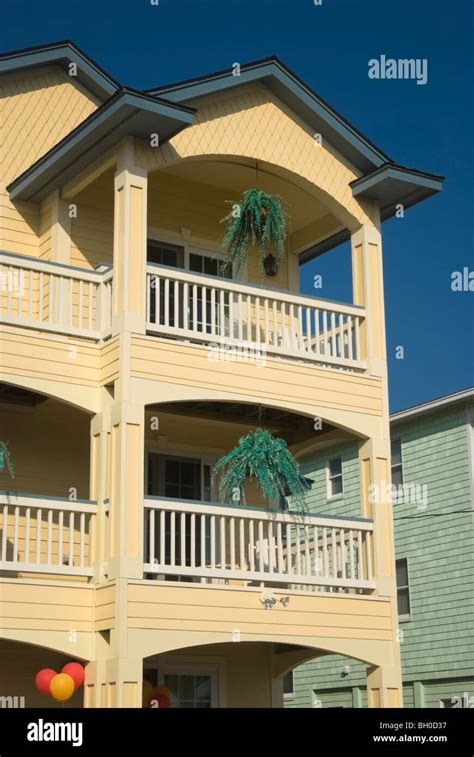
[{"left": 108, "top": 401, "right": 145, "bottom": 579}]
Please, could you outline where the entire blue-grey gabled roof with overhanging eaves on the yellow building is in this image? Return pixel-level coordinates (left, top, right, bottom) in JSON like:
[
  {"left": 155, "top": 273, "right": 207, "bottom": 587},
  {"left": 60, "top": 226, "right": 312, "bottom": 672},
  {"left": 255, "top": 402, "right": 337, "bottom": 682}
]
[{"left": 0, "top": 40, "right": 443, "bottom": 245}]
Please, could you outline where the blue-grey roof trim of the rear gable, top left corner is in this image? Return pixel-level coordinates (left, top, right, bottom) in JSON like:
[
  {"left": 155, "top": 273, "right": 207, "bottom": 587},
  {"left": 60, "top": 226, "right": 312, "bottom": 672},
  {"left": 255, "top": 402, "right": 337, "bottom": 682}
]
[{"left": 0, "top": 40, "right": 120, "bottom": 100}]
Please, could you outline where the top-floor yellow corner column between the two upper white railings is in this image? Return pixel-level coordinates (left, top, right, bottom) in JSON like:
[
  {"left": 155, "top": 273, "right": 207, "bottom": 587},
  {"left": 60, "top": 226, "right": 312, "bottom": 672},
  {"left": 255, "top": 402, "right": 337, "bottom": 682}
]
[{"left": 112, "top": 138, "right": 147, "bottom": 334}]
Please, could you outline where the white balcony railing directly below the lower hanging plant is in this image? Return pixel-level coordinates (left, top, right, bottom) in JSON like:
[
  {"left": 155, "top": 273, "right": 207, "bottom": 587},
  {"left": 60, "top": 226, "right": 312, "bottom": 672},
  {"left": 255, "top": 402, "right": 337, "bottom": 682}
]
[{"left": 144, "top": 497, "right": 375, "bottom": 591}]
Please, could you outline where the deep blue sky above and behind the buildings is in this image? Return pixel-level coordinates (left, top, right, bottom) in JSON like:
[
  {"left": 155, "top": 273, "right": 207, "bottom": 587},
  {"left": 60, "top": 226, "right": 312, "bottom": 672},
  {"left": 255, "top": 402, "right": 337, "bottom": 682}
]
[{"left": 0, "top": 0, "right": 474, "bottom": 410}]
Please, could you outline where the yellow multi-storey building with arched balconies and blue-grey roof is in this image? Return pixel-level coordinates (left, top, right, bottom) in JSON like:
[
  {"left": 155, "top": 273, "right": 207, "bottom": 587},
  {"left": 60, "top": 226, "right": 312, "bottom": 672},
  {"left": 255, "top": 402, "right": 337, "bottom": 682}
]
[{"left": 0, "top": 43, "right": 442, "bottom": 707}]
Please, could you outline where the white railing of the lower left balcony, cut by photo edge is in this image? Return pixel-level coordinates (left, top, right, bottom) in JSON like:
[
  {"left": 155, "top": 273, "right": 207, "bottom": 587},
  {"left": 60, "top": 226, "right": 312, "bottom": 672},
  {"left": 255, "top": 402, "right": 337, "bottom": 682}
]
[{"left": 0, "top": 492, "right": 97, "bottom": 576}]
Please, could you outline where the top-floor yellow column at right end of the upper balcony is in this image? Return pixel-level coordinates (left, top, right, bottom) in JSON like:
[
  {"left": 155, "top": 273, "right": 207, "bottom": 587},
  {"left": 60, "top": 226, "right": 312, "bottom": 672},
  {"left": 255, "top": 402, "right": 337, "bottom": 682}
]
[{"left": 351, "top": 224, "right": 387, "bottom": 377}]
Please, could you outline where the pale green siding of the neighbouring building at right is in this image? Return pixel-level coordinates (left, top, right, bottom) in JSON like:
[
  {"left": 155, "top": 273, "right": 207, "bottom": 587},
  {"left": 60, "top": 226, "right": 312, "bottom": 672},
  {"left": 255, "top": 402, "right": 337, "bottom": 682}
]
[{"left": 287, "top": 406, "right": 474, "bottom": 707}]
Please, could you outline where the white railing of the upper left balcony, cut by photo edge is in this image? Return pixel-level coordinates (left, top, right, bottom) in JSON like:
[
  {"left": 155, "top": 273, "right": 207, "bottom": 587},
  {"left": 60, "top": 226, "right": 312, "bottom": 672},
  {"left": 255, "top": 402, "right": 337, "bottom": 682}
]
[{"left": 0, "top": 253, "right": 112, "bottom": 339}]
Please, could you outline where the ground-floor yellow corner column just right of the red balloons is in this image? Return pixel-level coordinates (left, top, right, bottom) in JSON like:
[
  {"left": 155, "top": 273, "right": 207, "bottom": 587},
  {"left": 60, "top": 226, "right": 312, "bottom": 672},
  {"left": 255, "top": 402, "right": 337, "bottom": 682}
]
[{"left": 84, "top": 657, "right": 143, "bottom": 708}]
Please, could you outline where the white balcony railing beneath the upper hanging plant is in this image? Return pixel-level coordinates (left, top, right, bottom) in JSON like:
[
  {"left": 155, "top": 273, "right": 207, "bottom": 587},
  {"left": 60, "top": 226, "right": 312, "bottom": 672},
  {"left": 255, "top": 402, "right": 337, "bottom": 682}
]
[{"left": 146, "top": 265, "right": 365, "bottom": 369}]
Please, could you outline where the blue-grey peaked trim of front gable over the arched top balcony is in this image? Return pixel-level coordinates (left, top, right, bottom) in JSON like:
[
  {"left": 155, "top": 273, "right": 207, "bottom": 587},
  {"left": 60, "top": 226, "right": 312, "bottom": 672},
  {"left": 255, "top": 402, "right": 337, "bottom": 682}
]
[{"left": 147, "top": 56, "right": 391, "bottom": 173}]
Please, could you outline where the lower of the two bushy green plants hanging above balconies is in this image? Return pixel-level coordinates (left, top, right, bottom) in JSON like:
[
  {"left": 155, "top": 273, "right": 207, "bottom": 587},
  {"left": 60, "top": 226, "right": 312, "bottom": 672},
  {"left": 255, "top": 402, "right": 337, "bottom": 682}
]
[{"left": 214, "top": 428, "right": 309, "bottom": 510}]
